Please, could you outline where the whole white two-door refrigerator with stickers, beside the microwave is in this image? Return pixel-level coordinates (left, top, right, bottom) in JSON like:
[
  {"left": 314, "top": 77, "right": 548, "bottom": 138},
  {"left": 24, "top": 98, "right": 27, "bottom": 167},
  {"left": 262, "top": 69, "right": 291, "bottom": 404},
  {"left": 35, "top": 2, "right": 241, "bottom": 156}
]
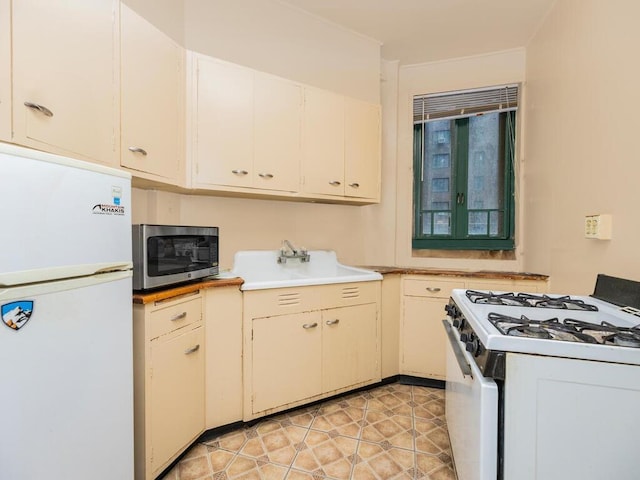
[{"left": 0, "top": 143, "right": 133, "bottom": 480}]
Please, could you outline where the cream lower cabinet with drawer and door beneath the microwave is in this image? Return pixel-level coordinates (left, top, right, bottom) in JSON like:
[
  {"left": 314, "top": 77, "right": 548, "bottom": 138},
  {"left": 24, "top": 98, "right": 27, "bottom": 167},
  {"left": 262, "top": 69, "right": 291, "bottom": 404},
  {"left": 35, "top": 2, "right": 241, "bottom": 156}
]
[{"left": 133, "top": 292, "right": 205, "bottom": 480}]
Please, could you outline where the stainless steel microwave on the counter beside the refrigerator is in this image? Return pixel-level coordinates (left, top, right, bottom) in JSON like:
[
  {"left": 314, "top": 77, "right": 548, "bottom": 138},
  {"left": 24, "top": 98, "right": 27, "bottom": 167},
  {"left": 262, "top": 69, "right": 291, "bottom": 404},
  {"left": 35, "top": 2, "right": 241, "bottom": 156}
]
[{"left": 132, "top": 224, "right": 219, "bottom": 290}]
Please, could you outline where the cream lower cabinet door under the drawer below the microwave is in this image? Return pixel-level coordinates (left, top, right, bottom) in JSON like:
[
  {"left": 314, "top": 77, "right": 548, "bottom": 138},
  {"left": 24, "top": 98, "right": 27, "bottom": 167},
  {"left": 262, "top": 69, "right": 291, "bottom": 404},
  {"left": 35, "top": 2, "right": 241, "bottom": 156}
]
[{"left": 147, "top": 327, "right": 205, "bottom": 478}]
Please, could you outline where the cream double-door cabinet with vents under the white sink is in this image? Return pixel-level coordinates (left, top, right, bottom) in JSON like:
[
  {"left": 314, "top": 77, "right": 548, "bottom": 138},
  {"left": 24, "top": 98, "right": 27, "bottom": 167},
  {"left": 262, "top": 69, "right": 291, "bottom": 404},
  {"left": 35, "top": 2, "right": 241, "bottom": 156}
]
[{"left": 244, "top": 282, "right": 380, "bottom": 421}]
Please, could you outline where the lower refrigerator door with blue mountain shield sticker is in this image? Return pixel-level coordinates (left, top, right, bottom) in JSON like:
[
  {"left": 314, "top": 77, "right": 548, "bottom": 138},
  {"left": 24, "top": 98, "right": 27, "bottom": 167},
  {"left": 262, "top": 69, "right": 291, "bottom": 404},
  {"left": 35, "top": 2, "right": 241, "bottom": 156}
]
[{"left": 0, "top": 271, "right": 133, "bottom": 480}]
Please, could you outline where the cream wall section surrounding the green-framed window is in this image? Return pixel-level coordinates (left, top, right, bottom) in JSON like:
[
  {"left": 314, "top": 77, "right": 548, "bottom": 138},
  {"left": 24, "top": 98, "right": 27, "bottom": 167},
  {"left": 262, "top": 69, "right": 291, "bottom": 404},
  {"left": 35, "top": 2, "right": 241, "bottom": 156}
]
[{"left": 390, "top": 49, "right": 525, "bottom": 271}]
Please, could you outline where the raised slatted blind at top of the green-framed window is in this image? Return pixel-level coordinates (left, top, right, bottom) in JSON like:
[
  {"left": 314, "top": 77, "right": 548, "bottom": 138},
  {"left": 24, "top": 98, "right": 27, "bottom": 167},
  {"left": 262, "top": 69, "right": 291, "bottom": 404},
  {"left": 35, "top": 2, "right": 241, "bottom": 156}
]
[{"left": 413, "top": 85, "right": 518, "bottom": 124}]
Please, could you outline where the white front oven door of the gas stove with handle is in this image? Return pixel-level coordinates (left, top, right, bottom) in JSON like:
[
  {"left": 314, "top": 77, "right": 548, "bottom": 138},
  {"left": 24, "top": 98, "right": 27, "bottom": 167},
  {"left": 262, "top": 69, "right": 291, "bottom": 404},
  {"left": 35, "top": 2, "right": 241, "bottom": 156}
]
[{"left": 443, "top": 320, "right": 498, "bottom": 480}]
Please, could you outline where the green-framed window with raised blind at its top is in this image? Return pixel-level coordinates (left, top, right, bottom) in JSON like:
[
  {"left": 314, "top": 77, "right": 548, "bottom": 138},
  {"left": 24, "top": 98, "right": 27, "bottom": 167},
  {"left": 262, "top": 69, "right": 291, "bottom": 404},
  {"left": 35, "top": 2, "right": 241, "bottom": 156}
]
[{"left": 412, "top": 86, "right": 517, "bottom": 250}]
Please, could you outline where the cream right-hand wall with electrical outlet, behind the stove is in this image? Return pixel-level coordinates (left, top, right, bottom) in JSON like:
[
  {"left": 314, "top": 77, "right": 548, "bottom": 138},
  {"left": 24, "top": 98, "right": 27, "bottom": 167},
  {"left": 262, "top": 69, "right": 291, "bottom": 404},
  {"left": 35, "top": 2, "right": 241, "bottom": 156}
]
[{"left": 524, "top": 0, "right": 640, "bottom": 294}]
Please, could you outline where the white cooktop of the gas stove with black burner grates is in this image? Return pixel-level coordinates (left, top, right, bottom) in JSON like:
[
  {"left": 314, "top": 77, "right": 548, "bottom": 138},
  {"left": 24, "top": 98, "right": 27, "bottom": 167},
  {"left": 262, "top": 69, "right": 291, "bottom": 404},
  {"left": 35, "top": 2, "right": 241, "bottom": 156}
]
[{"left": 451, "top": 290, "right": 640, "bottom": 365}]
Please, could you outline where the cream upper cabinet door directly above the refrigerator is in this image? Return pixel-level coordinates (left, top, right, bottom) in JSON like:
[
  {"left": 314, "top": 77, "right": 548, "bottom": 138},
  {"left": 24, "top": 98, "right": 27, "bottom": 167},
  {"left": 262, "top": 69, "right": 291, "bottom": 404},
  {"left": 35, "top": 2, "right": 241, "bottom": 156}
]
[{"left": 11, "top": 0, "right": 120, "bottom": 166}]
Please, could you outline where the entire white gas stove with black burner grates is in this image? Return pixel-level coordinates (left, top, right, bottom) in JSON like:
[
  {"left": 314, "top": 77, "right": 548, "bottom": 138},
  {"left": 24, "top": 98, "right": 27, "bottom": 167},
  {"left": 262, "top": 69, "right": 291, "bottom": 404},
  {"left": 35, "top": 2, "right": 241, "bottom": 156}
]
[{"left": 444, "top": 276, "right": 640, "bottom": 480}]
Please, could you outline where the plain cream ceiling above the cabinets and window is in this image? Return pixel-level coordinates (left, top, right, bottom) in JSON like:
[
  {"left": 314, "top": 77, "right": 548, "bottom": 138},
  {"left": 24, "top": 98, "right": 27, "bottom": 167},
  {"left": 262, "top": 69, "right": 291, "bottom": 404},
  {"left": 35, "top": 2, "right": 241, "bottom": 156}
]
[{"left": 284, "top": 0, "right": 556, "bottom": 65}]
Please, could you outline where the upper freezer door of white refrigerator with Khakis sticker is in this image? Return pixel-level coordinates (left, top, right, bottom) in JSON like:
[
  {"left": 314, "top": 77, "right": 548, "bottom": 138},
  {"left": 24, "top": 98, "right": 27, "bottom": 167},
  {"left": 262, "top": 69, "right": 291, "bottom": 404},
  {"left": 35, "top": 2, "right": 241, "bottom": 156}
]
[{"left": 0, "top": 143, "right": 131, "bottom": 286}]
